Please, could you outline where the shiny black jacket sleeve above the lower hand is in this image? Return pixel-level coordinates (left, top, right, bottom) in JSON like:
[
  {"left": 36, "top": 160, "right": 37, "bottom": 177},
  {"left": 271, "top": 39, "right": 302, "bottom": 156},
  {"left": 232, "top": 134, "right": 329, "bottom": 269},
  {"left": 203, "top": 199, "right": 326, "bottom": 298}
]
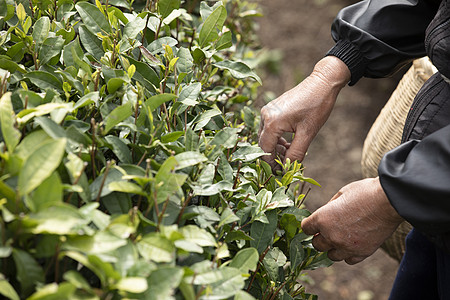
[{"left": 378, "top": 125, "right": 450, "bottom": 235}]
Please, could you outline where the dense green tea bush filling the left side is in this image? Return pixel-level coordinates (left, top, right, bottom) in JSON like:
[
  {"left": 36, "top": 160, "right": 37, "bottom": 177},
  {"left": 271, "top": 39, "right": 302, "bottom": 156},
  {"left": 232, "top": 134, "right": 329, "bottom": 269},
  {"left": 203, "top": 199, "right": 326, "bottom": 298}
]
[{"left": 0, "top": 0, "right": 330, "bottom": 300}]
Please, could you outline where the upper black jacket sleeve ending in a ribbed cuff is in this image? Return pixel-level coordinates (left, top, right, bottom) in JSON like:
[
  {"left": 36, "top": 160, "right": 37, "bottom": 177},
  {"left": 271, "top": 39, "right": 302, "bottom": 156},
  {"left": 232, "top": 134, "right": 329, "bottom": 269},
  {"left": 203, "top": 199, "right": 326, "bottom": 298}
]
[{"left": 327, "top": 0, "right": 439, "bottom": 85}]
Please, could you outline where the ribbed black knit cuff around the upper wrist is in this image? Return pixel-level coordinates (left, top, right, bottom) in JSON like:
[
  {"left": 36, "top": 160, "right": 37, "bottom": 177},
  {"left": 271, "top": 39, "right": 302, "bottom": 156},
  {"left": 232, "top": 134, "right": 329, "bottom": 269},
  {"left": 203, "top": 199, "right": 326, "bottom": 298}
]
[{"left": 325, "top": 40, "right": 366, "bottom": 85}]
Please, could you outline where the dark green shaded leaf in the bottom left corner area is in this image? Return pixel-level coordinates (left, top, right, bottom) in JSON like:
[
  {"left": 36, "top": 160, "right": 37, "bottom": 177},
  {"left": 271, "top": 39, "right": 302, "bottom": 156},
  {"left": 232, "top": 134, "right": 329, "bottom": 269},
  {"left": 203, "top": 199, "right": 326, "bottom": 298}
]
[{"left": 13, "top": 249, "right": 45, "bottom": 298}]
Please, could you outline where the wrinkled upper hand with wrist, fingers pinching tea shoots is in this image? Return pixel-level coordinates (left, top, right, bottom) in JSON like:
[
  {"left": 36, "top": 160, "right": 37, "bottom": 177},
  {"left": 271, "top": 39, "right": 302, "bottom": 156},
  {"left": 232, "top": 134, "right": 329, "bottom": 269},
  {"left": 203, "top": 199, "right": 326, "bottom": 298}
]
[{"left": 259, "top": 56, "right": 350, "bottom": 168}]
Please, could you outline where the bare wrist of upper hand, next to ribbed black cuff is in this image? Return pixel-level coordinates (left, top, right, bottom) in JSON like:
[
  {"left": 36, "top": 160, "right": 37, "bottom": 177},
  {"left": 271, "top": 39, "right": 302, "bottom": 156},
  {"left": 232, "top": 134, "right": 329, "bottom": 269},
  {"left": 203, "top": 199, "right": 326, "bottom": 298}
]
[{"left": 311, "top": 56, "right": 351, "bottom": 90}]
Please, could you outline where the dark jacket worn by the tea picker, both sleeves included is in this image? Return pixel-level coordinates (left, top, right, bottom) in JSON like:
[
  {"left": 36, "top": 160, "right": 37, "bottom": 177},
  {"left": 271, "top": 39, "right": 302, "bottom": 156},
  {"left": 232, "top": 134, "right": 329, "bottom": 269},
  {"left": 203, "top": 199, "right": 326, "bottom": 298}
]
[{"left": 328, "top": 0, "right": 450, "bottom": 252}]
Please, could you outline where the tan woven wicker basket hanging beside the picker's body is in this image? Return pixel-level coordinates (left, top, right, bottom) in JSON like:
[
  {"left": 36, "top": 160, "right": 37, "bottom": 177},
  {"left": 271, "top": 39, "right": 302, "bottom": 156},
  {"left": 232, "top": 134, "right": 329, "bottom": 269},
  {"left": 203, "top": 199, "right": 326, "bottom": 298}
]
[{"left": 361, "top": 57, "right": 437, "bottom": 261}]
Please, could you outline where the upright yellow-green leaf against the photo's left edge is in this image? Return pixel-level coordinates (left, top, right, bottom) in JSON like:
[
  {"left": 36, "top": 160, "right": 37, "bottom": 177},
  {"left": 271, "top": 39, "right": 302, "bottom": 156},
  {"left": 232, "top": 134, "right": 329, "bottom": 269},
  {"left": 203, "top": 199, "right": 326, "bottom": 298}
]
[{"left": 0, "top": 93, "right": 21, "bottom": 153}]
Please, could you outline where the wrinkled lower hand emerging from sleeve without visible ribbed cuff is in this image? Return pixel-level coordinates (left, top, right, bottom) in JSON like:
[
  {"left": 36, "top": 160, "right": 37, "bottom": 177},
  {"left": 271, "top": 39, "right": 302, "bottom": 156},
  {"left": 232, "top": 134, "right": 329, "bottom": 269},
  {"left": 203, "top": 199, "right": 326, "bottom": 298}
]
[{"left": 302, "top": 177, "right": 403, "bottom": 264}]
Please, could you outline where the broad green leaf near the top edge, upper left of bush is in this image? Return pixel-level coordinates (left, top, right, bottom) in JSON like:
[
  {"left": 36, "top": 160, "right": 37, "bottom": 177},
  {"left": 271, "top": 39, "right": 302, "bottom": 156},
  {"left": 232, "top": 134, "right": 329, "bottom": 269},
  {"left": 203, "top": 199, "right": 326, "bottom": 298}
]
[{"left": 75, "top": 2, "right": 112, "bottom": 34}]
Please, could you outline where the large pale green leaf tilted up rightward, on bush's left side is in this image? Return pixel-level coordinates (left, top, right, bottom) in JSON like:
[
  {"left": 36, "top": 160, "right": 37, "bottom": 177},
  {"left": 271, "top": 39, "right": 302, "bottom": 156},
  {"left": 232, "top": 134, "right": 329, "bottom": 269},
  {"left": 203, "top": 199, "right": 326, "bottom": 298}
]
[{"left": 18, "top": 139, "right": 66, "bottom": 195}]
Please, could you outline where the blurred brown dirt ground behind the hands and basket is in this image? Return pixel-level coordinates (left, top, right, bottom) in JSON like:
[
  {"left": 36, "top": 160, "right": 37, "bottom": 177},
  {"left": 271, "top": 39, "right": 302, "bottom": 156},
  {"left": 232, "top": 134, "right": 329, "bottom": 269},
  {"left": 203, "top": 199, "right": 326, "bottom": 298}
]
[{"left": 255, "top": 0, "right": 401, "bottom": 300}]
